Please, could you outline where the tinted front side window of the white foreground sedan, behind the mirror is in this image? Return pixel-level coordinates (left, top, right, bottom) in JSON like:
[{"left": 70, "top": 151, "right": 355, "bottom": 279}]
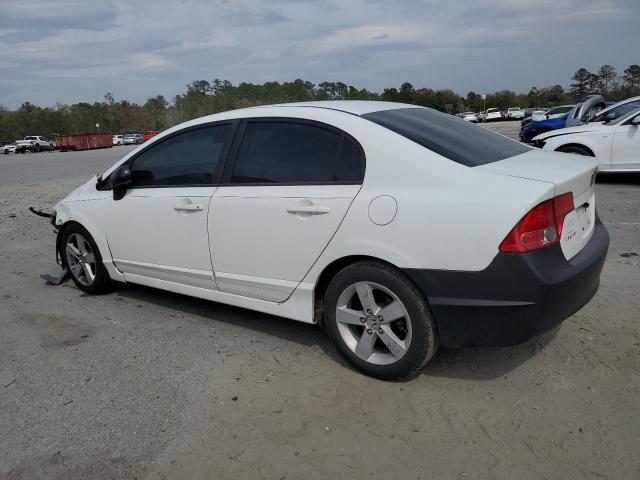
[{"left": 131, "top": 124, "right": 233, "bottom": 187}]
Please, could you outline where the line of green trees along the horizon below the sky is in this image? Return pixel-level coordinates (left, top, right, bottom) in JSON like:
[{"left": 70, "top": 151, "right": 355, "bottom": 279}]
[{"left": 0, "top": 65, "right": 640, "bottom": 140}]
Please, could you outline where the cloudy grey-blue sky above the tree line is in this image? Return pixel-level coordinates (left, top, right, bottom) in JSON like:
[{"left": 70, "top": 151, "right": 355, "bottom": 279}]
[{"left": 0, "top": 0, "right": 640, "bottom": 108}]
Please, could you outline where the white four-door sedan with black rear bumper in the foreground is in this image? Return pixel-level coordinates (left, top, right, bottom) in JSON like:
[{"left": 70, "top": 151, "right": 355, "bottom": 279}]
[{"left": 52, "top": 101, "right": 609, "bottom": 379}]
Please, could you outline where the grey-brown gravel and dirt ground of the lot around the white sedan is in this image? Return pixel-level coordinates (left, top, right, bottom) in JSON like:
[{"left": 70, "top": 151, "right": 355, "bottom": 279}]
[{"left": 0, "top": 139, "right": 640, "bottom": 479}]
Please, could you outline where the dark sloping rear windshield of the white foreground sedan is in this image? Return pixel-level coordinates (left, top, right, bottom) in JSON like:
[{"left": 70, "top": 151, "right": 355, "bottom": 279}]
[{"left": 362, "top": 108, "right": 530, "bottom": 167}]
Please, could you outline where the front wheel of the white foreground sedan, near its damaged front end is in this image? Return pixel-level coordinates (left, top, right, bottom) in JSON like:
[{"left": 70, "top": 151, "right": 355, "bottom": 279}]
[{"left": 60, "top": 223, "right": 112, "bottom": 294}]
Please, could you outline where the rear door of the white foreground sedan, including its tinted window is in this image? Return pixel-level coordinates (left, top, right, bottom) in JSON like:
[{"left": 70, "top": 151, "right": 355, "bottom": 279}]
[{"left": 209, "top": 119, "right": 364, "bottom": 302}]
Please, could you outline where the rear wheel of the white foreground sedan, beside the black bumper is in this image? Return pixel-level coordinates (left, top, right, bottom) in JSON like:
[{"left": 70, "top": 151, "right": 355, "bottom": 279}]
[{"left": 324, "top": 261, "right": 438, "bottom": 380}]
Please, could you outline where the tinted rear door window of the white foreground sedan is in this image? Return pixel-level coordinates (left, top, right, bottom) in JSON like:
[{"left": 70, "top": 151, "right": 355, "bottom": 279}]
[{"left": 231, "top": 121, "right": 364, "bottom": 185}]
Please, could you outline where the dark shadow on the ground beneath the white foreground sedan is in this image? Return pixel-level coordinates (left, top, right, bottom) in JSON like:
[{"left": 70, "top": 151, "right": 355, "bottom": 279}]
[{"left": 115, "top": 285, "right": 557, "bottom": 381}]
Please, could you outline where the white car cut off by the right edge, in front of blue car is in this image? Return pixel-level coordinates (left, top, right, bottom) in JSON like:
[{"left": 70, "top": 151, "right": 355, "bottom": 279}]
[{"left": 533, "top": 108, "right": 640, "bottom": 172}]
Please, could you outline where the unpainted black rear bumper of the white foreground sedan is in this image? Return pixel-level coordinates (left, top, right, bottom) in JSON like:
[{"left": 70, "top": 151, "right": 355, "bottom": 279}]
[{"left": 404, "top": 219, "right": 609, "bottom": 347}]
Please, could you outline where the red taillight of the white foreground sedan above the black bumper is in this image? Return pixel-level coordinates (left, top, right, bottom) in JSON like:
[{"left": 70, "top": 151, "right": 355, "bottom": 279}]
[{"left": 500, "top": 193, "right": 575, "bottom": 253}]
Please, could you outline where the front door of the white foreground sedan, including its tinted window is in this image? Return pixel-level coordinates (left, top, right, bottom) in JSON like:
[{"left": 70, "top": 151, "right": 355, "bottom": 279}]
[{"left": 103, "top": 123, "right": 234, "bottom": 289}]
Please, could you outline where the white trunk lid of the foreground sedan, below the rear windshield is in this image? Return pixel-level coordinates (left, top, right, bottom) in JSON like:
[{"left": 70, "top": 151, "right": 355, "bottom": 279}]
[{"left": 475, "top": 149, "right": 597, "bottom": 260}]
